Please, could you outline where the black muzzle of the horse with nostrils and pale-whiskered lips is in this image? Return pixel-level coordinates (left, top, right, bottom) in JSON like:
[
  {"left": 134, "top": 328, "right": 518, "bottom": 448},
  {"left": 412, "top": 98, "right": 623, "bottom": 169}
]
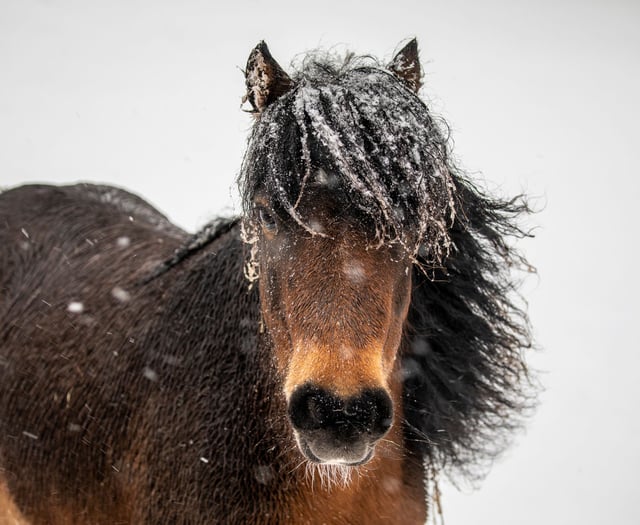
[{"left": 289, "top": 383, "right": 393, "bottom": 466}]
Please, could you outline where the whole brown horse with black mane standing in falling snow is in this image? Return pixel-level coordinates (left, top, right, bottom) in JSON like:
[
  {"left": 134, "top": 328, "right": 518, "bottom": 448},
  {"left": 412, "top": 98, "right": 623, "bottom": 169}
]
[{"left": 0, "top": 40, "right": 531, "bottom": 525}]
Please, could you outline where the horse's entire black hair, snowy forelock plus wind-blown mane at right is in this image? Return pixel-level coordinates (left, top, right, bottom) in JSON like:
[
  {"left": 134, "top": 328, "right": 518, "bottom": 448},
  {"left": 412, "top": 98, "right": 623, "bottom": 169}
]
[{"left": 239, "top": 54, "right": 531, "bottom": 476}]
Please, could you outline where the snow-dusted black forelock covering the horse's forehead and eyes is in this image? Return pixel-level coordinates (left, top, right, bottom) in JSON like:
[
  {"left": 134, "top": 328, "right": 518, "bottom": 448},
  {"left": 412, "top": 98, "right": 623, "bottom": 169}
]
[{"left": 240, "top": 53, "right": 455, "bottom": 262}]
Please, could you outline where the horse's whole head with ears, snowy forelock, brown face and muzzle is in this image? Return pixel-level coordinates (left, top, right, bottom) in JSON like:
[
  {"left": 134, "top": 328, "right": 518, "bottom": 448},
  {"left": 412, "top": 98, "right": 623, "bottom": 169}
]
[{"left": 240, "top": 40, "right": 453, "bottom": 465}]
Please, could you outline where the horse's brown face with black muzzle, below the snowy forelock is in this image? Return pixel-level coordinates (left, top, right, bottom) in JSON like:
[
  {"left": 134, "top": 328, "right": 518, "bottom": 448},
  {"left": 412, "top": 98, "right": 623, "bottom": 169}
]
[{"left": 256, "top": 182, "right": 411, "bottom": 465}]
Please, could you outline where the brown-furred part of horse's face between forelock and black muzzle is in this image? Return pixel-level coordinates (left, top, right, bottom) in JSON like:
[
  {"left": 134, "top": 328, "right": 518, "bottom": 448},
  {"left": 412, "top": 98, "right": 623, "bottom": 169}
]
[{"left": 255, "top": 192, "right": 411, "bottom": 397}]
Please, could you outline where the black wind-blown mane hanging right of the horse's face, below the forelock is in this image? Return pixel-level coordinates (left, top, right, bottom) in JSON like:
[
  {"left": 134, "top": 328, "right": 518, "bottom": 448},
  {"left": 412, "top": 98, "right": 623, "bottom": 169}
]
[{"left": 403, "top": 183, "right": 535, "bottom": 474}]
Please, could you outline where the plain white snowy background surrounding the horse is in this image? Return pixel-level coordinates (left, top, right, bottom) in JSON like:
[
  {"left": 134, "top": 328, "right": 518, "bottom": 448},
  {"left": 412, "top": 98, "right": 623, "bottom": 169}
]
[{"left": 0, "top": 0, "right": 640, "bottom": 525}]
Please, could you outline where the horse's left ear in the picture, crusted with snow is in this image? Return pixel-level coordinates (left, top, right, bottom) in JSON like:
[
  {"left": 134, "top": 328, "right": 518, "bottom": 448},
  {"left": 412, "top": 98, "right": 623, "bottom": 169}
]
[{"left": 242, "top": 41, "right": 293, "bottom": 113}]
